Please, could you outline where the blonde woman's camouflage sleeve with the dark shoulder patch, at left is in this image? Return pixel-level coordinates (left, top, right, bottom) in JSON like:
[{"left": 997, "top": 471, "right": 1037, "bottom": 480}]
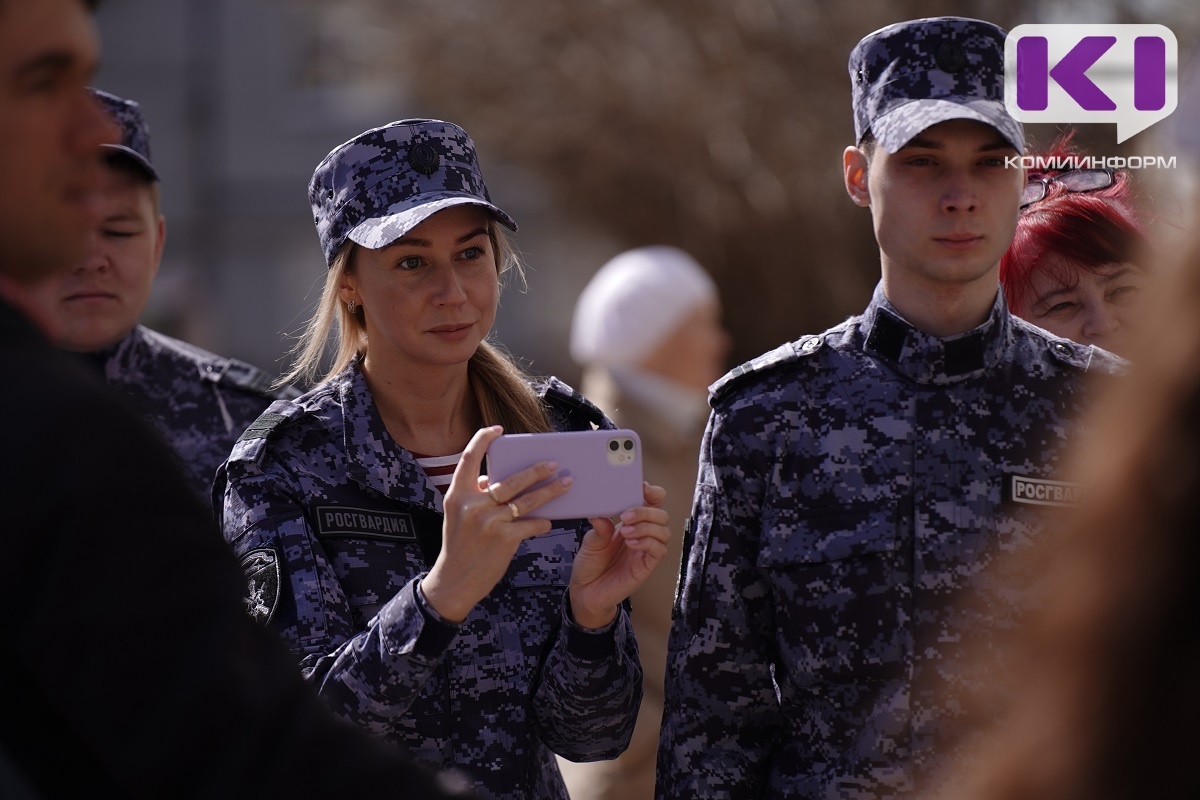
[{"left": 216, "top": 448, "right": 458, "bottom": 735}]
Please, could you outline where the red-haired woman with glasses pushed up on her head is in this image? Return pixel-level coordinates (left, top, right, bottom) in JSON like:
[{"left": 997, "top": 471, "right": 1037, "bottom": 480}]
[{"left": 1000, "top": 130, "right": 1153, "bottom": 356}]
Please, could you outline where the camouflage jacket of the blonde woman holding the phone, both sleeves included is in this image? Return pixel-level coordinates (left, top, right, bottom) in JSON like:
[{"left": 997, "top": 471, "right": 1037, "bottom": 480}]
[{"left": 215, "top": 363, "right": 642, "bottom": 800}]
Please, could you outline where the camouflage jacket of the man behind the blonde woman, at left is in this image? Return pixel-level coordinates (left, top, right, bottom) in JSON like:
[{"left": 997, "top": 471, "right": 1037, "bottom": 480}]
[{"left": 103, "top": 325, "right": 299, "bottom": 505}]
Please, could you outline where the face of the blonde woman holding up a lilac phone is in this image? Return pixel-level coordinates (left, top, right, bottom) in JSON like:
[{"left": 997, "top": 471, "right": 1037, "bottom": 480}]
[{"left": 340, "top": 205, "right": 500, "bottom": 369}]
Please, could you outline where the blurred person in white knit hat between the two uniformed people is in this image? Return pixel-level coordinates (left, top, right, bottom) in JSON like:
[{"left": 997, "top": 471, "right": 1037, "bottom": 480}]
[{"left": 563, "top": 246, "right": 730, "bottom": 800}]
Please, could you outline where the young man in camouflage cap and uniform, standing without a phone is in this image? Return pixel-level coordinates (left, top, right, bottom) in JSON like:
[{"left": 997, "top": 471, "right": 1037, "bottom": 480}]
[{"left": 658, "top": 17, "right": 1121, "bottom": 798}]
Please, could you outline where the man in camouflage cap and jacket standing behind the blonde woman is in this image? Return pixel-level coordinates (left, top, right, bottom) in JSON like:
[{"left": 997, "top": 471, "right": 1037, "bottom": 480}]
[{"left": 18, "top": 89, "right": 299, "bottom": 503}]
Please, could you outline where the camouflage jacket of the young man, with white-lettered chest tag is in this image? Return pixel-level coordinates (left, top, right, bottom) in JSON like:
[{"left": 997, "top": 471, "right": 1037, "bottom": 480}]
[{"left": 658, "top": 285, "right": 1123, "bottom": 800}]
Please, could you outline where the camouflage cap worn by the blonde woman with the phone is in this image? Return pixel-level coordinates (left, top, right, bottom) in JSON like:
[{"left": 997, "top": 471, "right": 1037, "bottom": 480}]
[{"left": 308, "top": 120, "right": 517, "bottom": 265}]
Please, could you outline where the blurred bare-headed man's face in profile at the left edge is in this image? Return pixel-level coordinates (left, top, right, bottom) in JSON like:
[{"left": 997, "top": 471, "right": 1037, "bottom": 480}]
[{"left": 0, "top": 0, "right": 111, "bottom": 282}]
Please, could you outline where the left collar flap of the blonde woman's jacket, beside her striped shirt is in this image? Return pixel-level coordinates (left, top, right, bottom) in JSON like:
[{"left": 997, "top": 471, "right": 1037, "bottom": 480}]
[{"left": 334, "top": 359, "right": 442, "bottom": 512}]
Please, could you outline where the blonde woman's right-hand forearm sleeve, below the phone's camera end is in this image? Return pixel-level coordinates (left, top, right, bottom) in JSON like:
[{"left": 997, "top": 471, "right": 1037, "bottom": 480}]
[{"left": 533, "top": 594, "right": 642, "bottom": 762}]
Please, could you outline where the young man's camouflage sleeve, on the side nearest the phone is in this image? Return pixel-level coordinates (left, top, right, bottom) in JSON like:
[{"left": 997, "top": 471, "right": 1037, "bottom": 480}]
[{"left": 658, "top": 402, "right": 781, "bottom": 799}]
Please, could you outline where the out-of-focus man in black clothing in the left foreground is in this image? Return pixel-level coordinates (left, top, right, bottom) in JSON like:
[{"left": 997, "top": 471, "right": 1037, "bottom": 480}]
[{"left": 0, "top": 0, "right": 477, "bottom": 799}]
